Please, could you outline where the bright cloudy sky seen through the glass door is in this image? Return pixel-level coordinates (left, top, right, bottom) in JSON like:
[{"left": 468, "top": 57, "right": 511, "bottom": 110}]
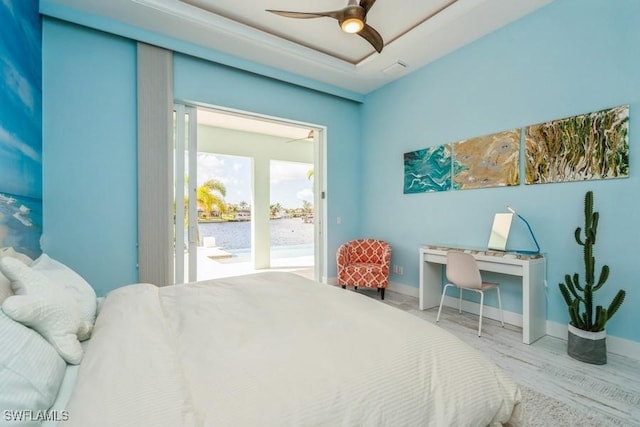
[{"left": 198, "top": 153, "right": 313, "bottom": 209}]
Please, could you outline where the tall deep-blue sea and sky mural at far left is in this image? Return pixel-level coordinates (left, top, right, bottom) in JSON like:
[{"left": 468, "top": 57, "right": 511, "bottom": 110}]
[{"left": 0, "top": 0, "right": 42, "bottom": 258}]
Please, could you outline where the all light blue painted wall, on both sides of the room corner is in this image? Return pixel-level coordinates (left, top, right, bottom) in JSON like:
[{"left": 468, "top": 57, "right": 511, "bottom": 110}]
[{"left": 43, "top": 0, "right": 640, "bottom": 341}]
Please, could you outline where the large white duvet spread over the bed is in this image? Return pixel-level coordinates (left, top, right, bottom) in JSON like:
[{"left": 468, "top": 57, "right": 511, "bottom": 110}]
[{"left": 62, "top": 272, "right": 520, "bottom": 427}]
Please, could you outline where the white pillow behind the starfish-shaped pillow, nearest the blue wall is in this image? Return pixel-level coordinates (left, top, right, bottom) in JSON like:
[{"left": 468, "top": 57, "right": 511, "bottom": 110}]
[{"left": 31, "top": 254, "right": 97, "bottom": 328}]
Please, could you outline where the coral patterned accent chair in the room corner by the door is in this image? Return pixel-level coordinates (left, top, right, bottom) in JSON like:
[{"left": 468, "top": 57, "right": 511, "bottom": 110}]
[{"left": 336, "top": 239, "right": 391, "bottom": 299}]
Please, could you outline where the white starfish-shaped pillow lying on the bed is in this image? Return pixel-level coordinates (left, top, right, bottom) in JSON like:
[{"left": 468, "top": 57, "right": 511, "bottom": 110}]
[{"left": 0, "top": 257, "right": 91, "bottom": 365}]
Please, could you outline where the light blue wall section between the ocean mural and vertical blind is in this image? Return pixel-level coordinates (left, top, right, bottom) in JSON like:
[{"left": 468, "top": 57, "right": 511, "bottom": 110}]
[{"left": 42, "top": 18, "right": 138, "bottom": 294}]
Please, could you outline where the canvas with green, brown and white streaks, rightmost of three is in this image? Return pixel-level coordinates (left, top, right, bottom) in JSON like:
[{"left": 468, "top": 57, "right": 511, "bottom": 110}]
[{"left": 525, "top": 105, "right": 629, "bottom": 184}]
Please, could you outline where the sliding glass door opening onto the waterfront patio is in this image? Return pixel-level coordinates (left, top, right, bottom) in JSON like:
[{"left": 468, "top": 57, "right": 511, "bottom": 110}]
[{"left": 172, "top": 104, "right": 325, "bottom": 283}]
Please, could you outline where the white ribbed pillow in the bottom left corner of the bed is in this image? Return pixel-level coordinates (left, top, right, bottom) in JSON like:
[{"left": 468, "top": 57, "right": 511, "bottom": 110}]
[{"left": 0, "top": 311, "right": 67, "bottom": 426}]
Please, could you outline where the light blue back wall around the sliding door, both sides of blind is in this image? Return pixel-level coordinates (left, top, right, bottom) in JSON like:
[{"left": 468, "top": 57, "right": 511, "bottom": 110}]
[{"left": 43, "top": 17, "right": 361, "bottom": 294}]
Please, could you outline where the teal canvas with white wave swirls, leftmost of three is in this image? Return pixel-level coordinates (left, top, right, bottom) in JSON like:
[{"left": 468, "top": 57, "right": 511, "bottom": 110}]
[{"left": 404, "top": 144, "right": 451, "bottom": 194}]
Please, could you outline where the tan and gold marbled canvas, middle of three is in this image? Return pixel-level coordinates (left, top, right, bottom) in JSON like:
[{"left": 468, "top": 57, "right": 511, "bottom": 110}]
[{"left": 453, "top": 129, "right": 520, "bottom": 190}]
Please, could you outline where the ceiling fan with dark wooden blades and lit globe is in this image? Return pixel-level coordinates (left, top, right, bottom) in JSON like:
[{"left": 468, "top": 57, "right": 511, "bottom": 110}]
[{"left": 267, "top": 0, "right": 384, "bottom": 53}]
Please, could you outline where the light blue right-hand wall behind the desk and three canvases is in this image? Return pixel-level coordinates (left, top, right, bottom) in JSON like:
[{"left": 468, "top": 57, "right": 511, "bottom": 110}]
[{"left": 362, "top": 0, "right": 640, "bottom": 341}]
